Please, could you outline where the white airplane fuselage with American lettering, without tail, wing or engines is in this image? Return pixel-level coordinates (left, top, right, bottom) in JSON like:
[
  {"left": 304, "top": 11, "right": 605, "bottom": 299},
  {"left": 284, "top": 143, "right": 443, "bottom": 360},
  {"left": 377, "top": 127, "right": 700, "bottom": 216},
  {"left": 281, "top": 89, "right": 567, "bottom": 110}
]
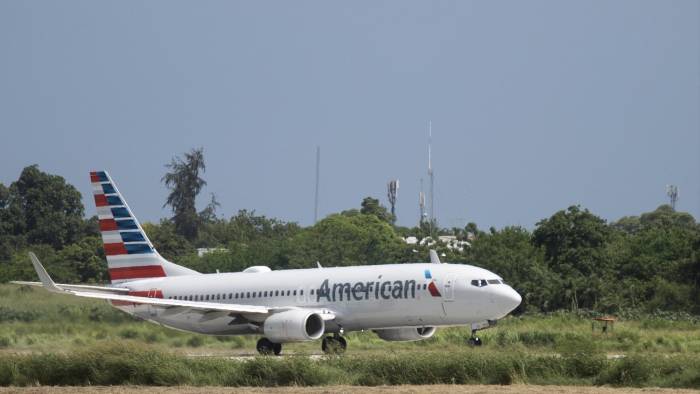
[{"left": 115, "top": 264, "right": 521, "bottom": 335}]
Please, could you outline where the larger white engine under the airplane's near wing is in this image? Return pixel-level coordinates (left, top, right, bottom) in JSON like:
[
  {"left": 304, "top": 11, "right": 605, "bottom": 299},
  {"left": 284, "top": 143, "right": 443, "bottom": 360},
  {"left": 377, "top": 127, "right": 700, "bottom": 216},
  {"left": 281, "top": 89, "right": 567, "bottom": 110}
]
[{"left": 263, "top": 309, "right": 326, "bottom": 343}]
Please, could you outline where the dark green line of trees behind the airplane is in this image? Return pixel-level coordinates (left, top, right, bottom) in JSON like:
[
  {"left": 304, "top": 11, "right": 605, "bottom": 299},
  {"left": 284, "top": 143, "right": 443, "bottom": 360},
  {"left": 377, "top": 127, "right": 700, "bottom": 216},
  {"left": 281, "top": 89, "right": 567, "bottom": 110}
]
[{"left": 0, "top": 160, "right": 700, "bottom": 314}]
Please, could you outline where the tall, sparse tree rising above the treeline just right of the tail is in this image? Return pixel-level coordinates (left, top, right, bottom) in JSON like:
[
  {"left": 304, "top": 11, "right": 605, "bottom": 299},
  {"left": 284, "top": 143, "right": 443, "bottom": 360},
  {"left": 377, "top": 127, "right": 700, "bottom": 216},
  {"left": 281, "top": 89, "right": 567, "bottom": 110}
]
[{"left": 162, "top": 148, "right": 207, "bottom": 241}]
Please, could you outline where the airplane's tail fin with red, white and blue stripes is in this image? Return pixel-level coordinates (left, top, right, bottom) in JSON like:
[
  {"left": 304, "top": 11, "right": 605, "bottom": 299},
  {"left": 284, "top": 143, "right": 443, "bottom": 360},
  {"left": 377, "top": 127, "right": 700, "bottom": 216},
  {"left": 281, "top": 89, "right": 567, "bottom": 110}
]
[{"left": 90, "top": 171, "right": 198, "bottom": 283}]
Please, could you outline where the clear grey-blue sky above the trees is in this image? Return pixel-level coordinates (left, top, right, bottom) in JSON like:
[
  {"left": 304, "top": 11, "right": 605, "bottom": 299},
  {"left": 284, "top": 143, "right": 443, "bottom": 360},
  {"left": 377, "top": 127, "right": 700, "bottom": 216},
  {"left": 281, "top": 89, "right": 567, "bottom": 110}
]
[{"left": 0, "top": 0, "right": 700, "bottom": 228}]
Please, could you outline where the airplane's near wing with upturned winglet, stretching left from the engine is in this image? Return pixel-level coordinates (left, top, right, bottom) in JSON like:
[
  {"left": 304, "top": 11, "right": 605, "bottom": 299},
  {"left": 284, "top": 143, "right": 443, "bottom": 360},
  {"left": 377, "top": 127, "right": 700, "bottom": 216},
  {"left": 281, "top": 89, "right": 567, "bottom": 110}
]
[{"left": 13, "top": 252, "right": 335, "bottom": 320}]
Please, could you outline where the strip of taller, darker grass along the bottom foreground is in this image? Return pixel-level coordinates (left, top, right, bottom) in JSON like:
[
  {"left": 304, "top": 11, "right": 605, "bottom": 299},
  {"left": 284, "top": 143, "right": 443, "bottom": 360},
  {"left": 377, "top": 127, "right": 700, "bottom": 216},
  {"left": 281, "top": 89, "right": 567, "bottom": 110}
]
[{"left": 0, "top": 342, "right": 700, "bottom": 388}]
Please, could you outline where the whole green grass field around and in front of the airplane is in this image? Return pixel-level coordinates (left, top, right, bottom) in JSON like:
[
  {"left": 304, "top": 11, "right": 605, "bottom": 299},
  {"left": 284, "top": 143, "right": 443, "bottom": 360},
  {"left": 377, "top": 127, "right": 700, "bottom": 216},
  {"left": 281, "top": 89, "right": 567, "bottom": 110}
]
[{"left": 0, "top": 285, "right": 700, "bottom": 388}]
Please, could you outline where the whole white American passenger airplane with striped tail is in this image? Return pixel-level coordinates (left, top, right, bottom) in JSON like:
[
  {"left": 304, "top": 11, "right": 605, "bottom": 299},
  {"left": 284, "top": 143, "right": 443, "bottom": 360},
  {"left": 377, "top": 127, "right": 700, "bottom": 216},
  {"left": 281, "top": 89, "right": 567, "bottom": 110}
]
[{"left": 13, "top": 171, "right": 521, "bottom": 355}]
